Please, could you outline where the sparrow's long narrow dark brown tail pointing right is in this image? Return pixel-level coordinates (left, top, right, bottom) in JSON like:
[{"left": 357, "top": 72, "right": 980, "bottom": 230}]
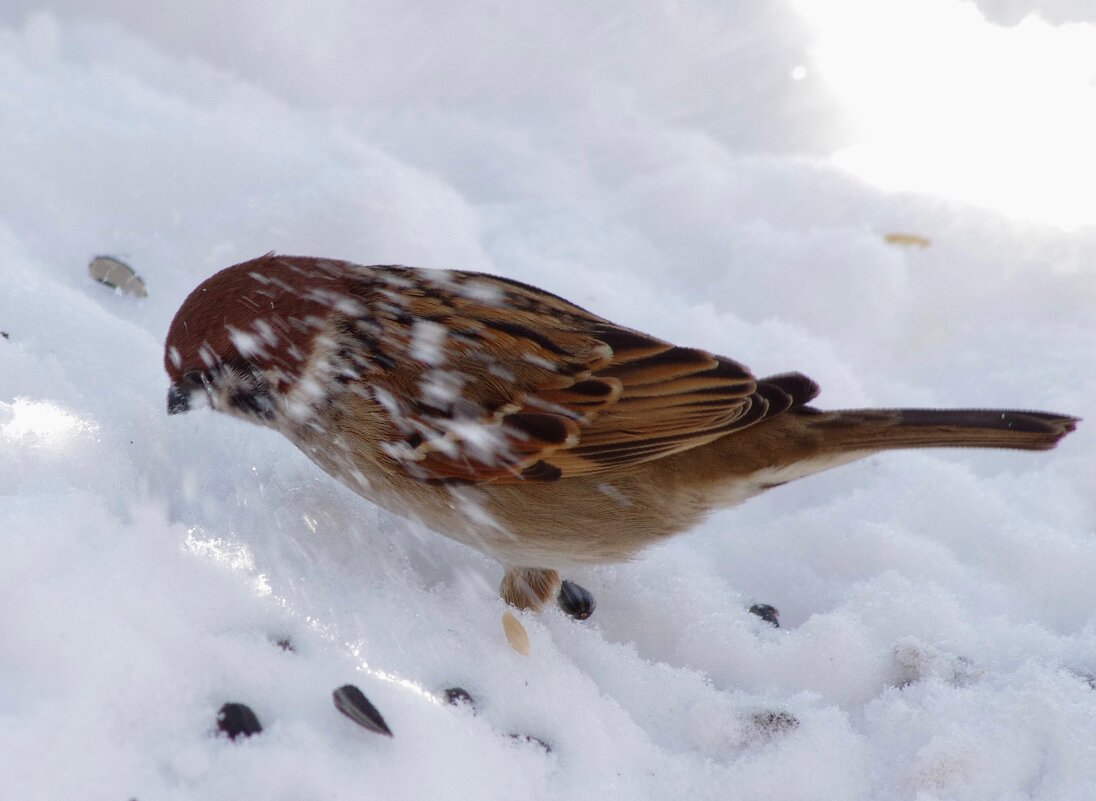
[{"left": 798, "top": 407, "right": 1080, "bottom": 451}]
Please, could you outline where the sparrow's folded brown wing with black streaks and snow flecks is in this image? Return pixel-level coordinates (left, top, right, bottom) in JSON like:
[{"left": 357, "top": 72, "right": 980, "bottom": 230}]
[{"left": 342, "top": 267, "right": 791, "bottom": 483}]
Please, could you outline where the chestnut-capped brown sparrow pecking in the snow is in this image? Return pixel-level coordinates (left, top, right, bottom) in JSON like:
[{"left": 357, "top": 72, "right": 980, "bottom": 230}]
[{"left": 164, "top": 254, "right": 1077, "bottom": 608}]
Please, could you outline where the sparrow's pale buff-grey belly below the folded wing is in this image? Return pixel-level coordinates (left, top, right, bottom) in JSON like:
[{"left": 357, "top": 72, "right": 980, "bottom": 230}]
[{"left": 290, "top": 407, "right": 866, "bottom": 570}]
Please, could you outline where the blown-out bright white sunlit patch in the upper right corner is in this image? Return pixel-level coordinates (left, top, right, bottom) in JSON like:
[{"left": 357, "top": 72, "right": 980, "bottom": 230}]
[{"left": 797, "top": 0, "right": 1096, "bottom": 230}]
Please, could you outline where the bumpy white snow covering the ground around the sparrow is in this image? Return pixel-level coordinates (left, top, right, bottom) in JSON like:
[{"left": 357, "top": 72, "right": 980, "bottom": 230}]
[{"left": 0, "top": 0, "right": 1096, "bottom": 801}]
